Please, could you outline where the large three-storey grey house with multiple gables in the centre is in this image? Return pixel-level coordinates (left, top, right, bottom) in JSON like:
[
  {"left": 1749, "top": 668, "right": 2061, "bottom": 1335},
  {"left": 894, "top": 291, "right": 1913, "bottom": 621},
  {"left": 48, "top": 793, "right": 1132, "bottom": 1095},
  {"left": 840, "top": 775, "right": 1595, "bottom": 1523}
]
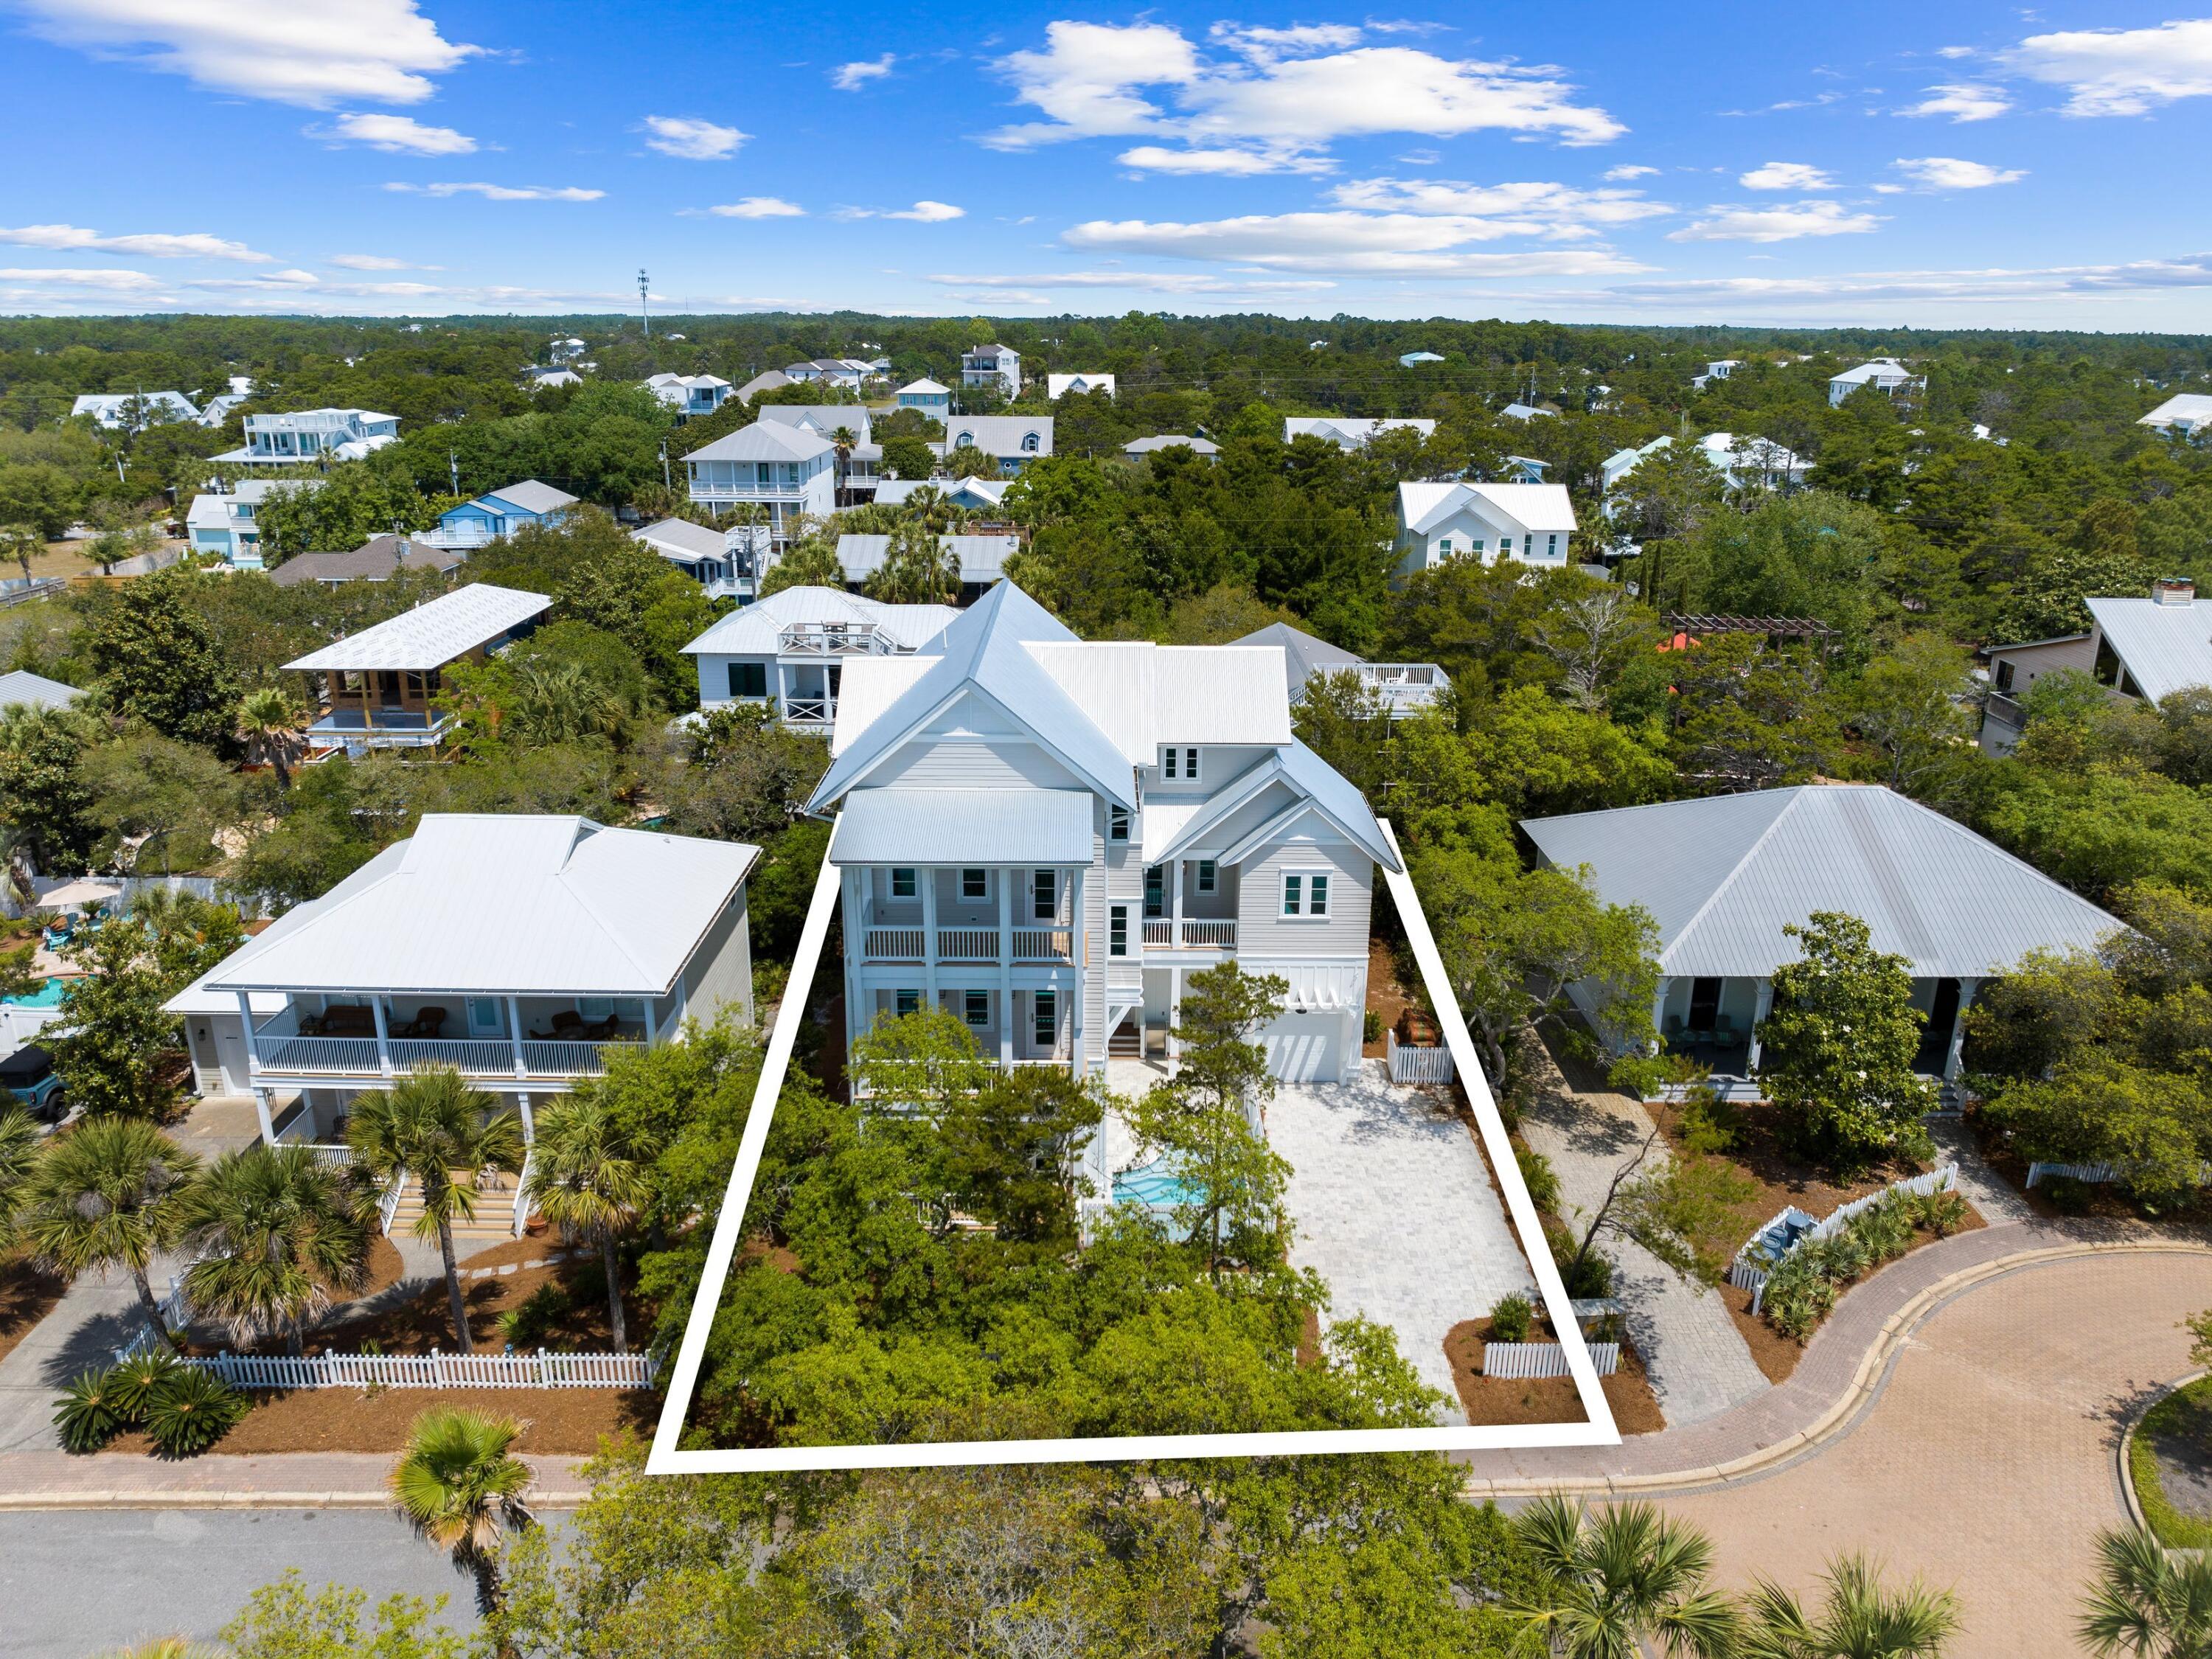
[{"left": 807, "top": 582, "right": 1398, "bottom": 1079}]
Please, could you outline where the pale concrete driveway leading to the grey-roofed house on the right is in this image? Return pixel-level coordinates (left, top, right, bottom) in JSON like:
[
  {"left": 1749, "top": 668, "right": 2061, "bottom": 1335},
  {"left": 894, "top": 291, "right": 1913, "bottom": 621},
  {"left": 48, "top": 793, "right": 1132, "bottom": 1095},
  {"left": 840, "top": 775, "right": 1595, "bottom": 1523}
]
[{"left": 1520, "top": 1073, "right": 1770, "bottom": 1429}]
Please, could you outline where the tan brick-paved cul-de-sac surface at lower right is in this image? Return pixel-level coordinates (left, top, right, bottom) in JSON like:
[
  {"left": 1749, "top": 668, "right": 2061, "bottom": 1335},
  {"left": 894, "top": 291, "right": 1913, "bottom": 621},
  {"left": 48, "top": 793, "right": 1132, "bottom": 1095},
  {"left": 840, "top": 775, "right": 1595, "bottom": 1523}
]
[{"left": 1663, "top": 1254, "right": 2212, "bottom": 1659}]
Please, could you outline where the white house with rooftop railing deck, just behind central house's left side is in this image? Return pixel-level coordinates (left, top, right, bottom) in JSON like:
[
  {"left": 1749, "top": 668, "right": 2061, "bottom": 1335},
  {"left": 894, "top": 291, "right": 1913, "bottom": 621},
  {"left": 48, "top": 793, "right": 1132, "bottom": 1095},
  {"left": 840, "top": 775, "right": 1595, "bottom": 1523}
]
[{"left": 684, "top": 588, "right": 960, "bottom": 732}]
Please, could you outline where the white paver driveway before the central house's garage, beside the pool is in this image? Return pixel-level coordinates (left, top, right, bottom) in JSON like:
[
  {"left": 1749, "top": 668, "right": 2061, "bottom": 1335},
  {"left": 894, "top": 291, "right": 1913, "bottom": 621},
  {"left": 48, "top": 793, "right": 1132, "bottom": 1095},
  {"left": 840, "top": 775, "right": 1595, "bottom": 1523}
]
[{"left": 1267, "top": 1060, "right": 1535, "bottom": 1420}]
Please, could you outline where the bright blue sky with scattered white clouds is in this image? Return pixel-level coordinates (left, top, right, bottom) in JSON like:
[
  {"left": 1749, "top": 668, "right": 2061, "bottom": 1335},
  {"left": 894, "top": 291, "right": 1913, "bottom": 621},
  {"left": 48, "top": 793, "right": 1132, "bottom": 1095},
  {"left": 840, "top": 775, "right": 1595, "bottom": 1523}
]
[{"left": 0, "top": 0, "right": 2212, "bottom": 332}]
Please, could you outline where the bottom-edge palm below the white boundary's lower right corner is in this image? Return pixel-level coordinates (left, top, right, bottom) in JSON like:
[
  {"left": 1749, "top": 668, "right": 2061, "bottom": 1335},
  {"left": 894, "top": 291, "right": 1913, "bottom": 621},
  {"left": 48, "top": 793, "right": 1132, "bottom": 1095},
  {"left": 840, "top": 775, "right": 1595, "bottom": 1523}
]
[{"left": 1515, "top": 1493, "right": 1741, "bottom": 1659}]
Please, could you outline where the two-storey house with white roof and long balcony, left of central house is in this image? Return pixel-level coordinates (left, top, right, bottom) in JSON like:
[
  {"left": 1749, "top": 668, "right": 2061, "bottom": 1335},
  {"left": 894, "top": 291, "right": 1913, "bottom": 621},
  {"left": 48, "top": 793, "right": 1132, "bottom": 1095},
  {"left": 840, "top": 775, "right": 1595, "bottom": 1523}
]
[{"left": 166, "top": 812, "right": 761, "bottom": 1159}]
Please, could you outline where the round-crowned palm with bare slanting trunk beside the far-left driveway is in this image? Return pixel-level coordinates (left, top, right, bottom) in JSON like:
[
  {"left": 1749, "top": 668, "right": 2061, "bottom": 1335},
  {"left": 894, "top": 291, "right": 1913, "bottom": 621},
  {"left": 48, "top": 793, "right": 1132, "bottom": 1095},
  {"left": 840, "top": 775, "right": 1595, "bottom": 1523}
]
[{"left": 18, "top": 1115, "right": 199, "bottom": 1345}]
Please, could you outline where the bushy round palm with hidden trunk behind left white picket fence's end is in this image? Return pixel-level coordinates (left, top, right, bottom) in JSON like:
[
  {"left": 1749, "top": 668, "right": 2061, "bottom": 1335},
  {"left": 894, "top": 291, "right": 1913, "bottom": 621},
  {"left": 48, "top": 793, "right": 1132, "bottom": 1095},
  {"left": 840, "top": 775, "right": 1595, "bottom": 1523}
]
[{"left": 184, "top": 1144, "right": 369, "bottom": 1354}]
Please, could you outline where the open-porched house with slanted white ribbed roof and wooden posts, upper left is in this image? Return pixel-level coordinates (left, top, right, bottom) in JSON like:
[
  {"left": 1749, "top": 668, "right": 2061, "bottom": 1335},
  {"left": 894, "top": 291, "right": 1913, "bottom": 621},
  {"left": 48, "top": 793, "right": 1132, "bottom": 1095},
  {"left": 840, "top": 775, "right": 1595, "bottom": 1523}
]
[{"left": 285, "top": 582, "right": 553, "bottom": 759}]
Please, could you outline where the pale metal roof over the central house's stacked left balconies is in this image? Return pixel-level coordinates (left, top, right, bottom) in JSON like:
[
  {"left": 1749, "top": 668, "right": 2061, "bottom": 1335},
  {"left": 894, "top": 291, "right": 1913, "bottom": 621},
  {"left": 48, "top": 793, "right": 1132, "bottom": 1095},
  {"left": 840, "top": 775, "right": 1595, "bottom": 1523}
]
[{"left": 830, "top": 790, "right": 1093, "bottom": 865}]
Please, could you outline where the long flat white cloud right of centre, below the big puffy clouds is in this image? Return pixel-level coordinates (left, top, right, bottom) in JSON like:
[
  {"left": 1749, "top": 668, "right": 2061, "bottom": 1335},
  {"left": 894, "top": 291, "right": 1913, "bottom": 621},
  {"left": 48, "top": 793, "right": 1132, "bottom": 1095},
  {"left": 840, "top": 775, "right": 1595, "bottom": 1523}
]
[{"left": 1062, "top": 212, "right": 1646, "bottom": 276}]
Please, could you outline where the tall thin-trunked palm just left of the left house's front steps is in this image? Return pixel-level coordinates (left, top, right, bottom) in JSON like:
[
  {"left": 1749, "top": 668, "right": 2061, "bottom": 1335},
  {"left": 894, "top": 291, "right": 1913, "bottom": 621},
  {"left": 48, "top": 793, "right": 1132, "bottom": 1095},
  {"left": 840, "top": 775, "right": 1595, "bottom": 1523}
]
[{"left": 347, "top": 1066, "right": 522, "bottom": 1354}]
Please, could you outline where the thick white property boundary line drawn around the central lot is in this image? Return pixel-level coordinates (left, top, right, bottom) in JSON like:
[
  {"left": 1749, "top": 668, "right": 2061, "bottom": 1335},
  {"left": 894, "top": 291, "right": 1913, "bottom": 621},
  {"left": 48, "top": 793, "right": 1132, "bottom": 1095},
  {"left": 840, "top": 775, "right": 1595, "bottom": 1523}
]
[{"left": 646, "top": 821, "right": 1621, "bottom": 1475}]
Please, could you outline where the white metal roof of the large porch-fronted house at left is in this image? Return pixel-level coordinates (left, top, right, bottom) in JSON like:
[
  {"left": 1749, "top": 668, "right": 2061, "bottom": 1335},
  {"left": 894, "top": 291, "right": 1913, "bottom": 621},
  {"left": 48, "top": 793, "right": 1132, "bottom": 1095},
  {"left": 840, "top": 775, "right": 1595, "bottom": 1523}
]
[{"left": 204, "top": 812, "right": 761, "bottom": 995}]
